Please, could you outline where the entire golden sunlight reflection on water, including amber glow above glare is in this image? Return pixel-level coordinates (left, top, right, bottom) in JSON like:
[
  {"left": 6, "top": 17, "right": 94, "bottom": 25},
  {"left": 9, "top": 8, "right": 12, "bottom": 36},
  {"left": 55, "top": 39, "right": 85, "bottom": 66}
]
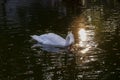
[{"left": 71, "top": 13, "right": 98, "bottom": 66}]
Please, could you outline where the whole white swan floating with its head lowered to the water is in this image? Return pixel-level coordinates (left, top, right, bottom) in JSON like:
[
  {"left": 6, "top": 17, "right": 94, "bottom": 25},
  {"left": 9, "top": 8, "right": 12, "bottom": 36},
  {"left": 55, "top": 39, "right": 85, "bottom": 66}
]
[{"left": 31, "top": 32, "right": 74, "bottom": 48}]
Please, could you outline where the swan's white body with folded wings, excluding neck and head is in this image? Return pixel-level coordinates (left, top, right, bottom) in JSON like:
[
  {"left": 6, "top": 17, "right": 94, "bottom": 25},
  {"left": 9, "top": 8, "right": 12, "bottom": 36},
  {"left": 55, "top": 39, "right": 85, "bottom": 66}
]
[{"left": 31, "top": 33, "right": 65, "bottom": 46}]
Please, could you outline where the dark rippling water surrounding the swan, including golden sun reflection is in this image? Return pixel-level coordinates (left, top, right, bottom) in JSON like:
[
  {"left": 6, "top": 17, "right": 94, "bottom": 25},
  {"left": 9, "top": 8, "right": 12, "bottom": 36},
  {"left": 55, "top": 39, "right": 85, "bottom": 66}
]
[{"left": 0, "top": 0, "right": 120, "bottom": 80}]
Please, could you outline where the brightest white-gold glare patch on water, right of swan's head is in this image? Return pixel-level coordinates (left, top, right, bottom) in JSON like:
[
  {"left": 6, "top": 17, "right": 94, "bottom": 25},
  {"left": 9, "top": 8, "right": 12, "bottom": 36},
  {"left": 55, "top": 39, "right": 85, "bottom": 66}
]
[{"left": 78, "top": 28, "right": 95, "bottom": 54}]
